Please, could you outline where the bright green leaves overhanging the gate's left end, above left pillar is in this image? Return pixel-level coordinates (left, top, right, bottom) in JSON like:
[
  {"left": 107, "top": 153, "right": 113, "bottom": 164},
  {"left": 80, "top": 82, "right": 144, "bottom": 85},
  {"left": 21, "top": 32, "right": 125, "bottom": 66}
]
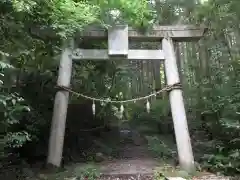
[{"left": 13, "top": 0, "right": 100, "bottom": 39}]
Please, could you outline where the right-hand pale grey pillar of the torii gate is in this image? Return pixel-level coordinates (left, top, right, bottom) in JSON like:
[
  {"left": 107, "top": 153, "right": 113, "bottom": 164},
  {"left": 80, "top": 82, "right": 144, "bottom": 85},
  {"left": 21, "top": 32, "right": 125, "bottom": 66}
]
[{"left": 162, "top": 38, "right": 195, "bottom": 172}]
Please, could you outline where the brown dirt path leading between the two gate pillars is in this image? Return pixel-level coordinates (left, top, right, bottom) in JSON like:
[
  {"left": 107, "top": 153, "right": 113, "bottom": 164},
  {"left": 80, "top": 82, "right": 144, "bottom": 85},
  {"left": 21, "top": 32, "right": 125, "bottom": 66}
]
[{"left": 100, "top": 131, "right": 162, "bottom": 175}]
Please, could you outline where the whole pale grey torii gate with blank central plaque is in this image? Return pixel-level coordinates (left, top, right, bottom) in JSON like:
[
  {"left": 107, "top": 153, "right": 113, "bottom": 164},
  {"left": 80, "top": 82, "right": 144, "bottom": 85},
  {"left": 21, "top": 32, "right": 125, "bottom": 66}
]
[{"left": 47, "top": 25, "right": 205, "bottom": 172}]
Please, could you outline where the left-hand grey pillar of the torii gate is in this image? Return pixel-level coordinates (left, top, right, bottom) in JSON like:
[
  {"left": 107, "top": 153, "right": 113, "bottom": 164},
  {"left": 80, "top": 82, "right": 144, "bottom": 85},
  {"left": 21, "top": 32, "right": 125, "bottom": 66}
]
[{"left": 47, "top": 45, "right": 72, "bottom": 167}]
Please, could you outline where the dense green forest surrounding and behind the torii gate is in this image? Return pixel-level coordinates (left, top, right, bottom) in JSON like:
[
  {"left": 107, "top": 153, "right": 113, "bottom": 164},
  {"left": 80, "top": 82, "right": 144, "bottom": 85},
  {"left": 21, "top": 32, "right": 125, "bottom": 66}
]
[{"left": 0, "top": 0, "right": 240, "bottom": 180}]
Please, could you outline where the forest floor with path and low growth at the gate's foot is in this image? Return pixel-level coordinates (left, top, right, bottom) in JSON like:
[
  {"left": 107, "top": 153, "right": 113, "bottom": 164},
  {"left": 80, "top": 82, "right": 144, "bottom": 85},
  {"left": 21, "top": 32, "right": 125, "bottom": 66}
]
[{"left": 32, "top": 127, "right": 233, "bottom": 180}]
